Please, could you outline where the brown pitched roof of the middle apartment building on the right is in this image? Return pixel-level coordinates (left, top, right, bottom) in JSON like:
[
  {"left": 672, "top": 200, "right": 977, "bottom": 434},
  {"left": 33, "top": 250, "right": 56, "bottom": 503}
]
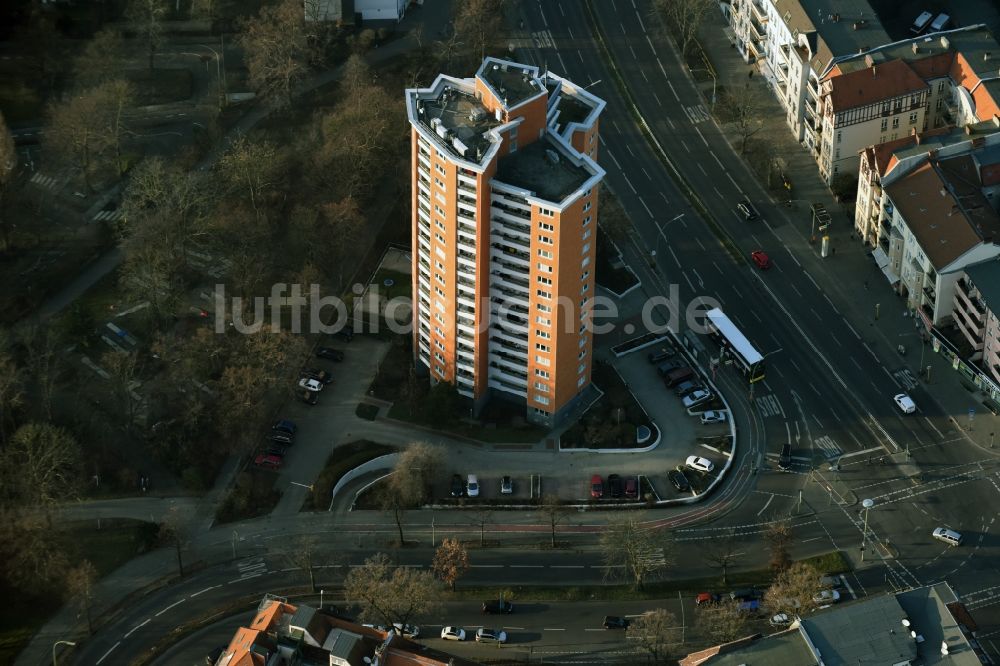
[{"left": 885, "top": 154, "right": 1000, "bottom": 270}]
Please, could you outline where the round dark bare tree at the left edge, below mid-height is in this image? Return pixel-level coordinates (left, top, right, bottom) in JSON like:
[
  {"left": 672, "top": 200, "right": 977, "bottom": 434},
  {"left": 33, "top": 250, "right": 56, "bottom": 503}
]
[{"left": 3, "top": 423, "right": 83, "bottom": 513}]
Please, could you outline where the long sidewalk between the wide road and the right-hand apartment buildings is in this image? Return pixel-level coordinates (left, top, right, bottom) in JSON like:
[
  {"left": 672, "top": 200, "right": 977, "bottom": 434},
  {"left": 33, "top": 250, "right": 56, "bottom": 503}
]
[{"left": 698, "top": 12, "right": 1000, "bottom": 451}]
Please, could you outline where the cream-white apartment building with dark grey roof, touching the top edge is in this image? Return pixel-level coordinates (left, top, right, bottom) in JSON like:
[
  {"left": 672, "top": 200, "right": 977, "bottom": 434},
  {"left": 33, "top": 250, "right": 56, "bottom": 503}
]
[{"left": 730, "top": 0, "right": 890, "bottom": 150}]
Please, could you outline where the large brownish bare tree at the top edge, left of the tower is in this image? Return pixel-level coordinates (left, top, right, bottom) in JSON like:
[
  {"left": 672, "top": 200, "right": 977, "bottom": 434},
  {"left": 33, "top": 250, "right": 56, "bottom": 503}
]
[{"left": 239, "top": 0, "right": 309, "bottom": 106}]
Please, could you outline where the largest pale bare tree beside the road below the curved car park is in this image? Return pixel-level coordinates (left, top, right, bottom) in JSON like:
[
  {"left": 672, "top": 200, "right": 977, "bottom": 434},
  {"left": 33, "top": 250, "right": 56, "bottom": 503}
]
[{"left": 600, "top": 513, "right": 673, "bottom": 589}]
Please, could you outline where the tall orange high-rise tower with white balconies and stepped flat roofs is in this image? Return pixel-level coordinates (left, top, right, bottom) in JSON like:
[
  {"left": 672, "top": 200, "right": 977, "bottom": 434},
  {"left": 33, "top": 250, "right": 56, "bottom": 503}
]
[{"left": 406, "top": 58, "right": 604, "bottom": 425}]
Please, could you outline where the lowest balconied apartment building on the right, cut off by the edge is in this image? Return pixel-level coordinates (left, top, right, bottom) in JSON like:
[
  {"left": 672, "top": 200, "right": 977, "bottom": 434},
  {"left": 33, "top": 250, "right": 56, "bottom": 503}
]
[{"left": 954, "top": 260, "right": 1000, "bottom": 384}]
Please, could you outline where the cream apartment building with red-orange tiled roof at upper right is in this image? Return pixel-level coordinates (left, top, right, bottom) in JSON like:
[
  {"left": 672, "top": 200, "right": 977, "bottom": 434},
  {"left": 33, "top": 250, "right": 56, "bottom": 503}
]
[{"left": 813, "top": 25, "right": 1000, "bottom": 183}]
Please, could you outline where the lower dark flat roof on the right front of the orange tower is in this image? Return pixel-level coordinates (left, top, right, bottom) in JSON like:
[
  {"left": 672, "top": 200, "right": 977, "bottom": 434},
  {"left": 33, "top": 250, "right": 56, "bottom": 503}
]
[{"left": 496, "top": 135, "right": 593, "bottom": 203}]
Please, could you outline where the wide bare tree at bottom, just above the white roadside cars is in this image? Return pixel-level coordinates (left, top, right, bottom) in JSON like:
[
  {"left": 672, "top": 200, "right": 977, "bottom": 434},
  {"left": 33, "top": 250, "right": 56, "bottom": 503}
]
[{"left": 344, "top": 553, "right": 440, "bottom": 627}]
